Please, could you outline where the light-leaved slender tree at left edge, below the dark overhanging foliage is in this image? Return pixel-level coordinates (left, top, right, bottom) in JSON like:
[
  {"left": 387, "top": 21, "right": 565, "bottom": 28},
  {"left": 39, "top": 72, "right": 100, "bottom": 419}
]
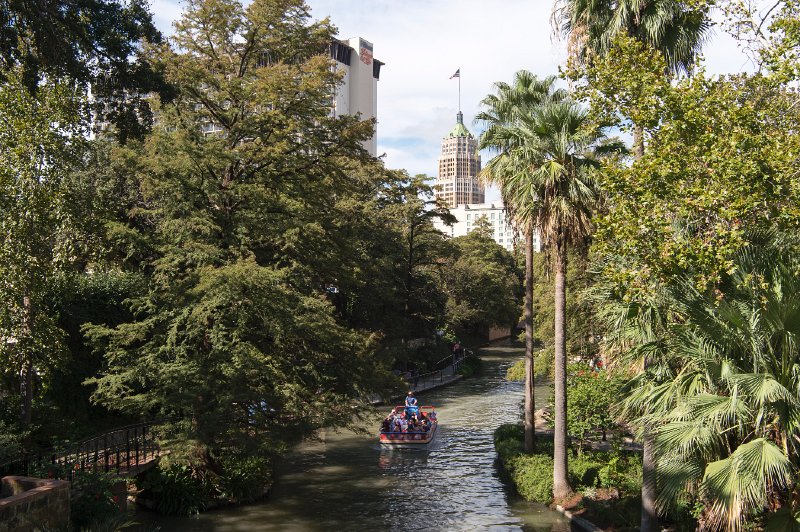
[{"left": 0, "top": 68, "right": 85, "bottom": 430}]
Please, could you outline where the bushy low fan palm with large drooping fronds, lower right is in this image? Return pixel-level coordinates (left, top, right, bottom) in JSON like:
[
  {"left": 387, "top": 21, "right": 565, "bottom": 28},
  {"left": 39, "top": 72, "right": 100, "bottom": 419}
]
[{"left": 604, "top": 233, "right": 800, "bottom": 530}]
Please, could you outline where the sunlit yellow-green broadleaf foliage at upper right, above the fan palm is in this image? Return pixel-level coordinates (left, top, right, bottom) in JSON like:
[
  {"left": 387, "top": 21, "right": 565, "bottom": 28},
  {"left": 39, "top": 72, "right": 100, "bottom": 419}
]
[{"left": 587, "top": 35, "right": 800, "bottom": 290}]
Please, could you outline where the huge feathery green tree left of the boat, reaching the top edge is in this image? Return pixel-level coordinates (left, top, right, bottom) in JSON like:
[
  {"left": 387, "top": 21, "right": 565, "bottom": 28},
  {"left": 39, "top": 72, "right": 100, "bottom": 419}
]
[{"left": 86, "top": 0, "right": 386, "bottom": 473}]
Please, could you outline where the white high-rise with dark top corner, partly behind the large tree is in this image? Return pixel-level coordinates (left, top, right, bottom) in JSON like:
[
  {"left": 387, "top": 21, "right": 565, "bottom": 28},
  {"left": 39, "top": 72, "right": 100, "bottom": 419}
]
[{"left": 331, "top": 37, "right": 384, "bottom": 157}]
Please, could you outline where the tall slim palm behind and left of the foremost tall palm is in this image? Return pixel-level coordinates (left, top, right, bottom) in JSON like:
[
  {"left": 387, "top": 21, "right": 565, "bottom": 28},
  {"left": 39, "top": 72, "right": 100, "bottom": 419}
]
[{"left": 475, "top": 70, "right": 566, "bottom": 452}]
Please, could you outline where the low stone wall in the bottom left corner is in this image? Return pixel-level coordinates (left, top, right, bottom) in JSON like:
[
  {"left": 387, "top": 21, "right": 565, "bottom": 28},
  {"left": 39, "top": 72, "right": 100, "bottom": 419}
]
[{"left": 0, "top": 477, "right": 69, "bottom": 532}]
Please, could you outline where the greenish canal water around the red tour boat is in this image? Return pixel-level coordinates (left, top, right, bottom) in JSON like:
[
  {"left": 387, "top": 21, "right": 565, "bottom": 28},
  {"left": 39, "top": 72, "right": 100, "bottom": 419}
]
[{"left": 137, "top": 347, "right": 570, "bottom": 532}]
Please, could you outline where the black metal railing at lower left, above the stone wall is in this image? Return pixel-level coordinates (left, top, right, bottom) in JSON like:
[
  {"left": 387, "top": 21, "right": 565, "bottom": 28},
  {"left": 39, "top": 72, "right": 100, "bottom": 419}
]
[{"left": 0, "top": 422, "right": 160, "bottom": 480}]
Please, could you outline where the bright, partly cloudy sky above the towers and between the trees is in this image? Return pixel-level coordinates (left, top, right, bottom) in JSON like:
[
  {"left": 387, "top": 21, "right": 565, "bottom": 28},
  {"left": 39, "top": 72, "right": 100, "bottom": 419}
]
[{"left": 151, "top": 0, "right": 753, "bottom": 201}]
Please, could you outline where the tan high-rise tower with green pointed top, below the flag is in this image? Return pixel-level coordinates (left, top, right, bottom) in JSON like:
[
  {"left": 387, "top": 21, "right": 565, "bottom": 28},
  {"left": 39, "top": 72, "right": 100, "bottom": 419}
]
[{"left": 434, "top": 111, "right": 486, "bottom": 207}]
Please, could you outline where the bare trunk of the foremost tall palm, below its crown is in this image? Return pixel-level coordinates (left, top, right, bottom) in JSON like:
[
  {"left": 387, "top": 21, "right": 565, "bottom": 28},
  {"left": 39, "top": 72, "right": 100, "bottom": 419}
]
[{"left": 553, "top": 231, "right": 572, "bottom": 499}]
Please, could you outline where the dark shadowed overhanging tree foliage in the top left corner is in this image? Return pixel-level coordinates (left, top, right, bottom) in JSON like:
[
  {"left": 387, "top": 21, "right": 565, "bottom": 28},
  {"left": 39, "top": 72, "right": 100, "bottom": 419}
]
[{"left": 0, "top": 0, "right": 171, "bottom": 140}]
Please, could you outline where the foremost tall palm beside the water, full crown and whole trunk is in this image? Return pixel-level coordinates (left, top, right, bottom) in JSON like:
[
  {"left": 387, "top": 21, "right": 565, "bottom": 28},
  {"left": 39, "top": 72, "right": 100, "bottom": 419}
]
[{"left": 484, "top": 84, "right": 620, "bottom": 498}]
